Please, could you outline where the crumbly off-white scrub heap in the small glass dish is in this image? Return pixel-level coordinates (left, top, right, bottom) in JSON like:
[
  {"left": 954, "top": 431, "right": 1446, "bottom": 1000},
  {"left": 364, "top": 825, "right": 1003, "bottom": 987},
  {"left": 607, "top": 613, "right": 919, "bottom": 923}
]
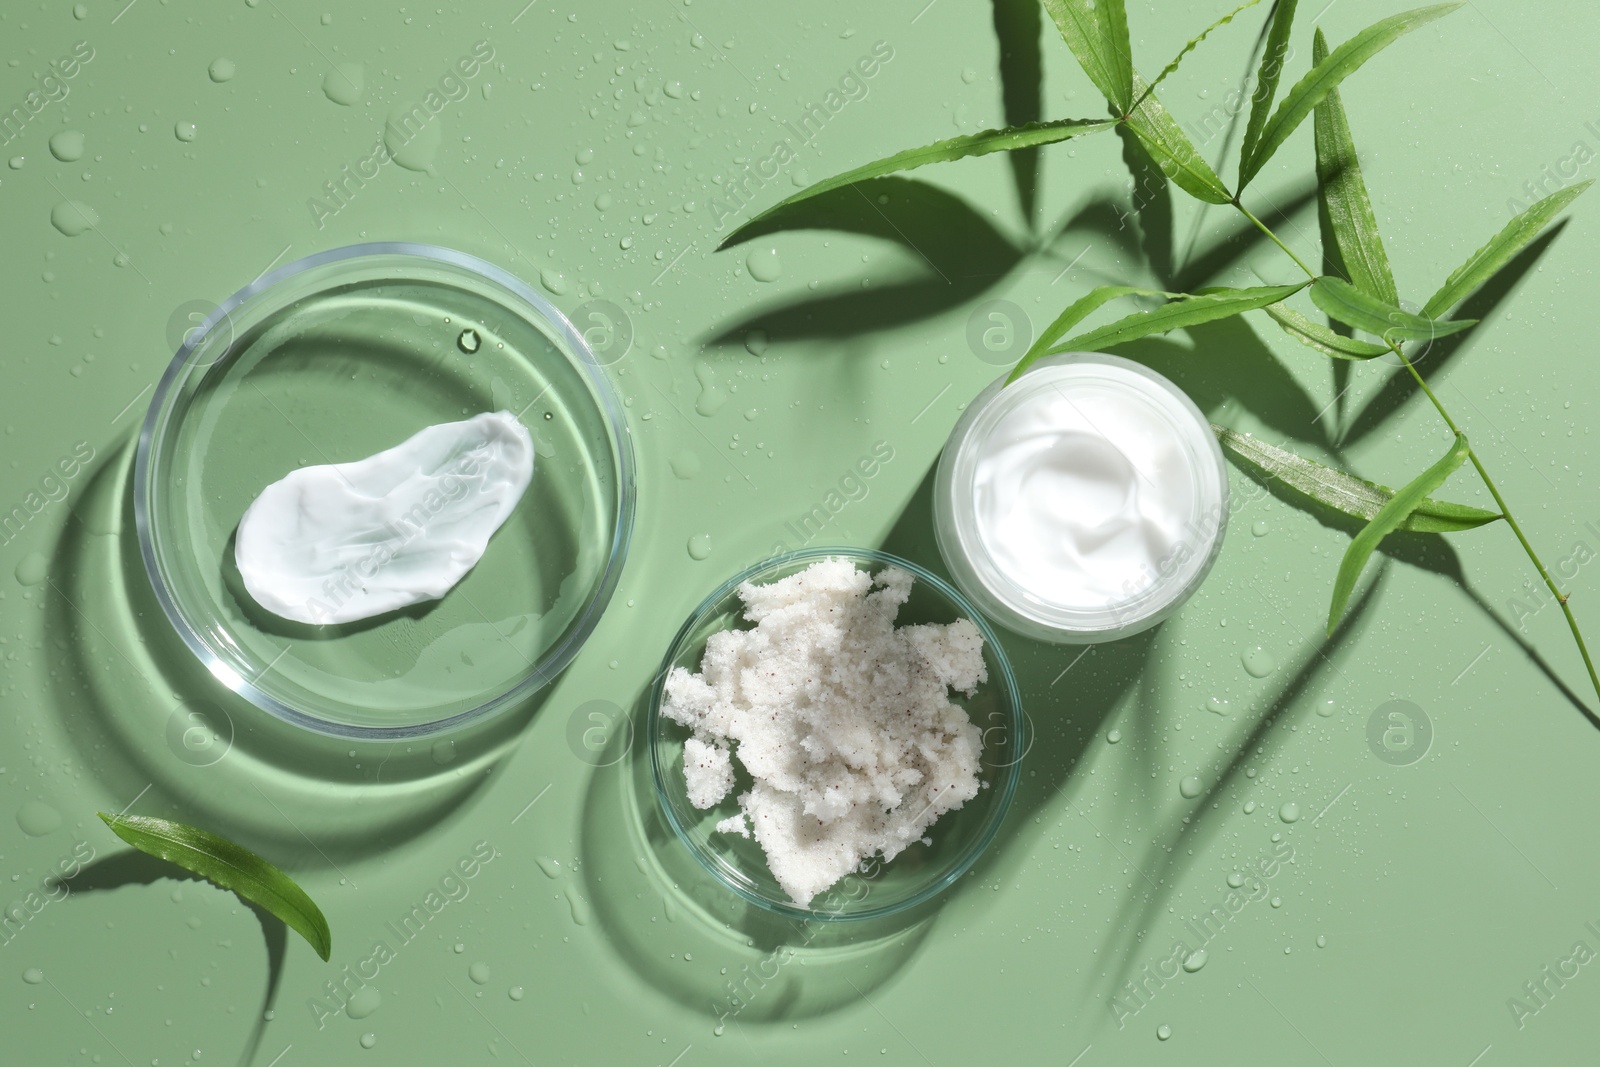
[{"left": 661, "top": 558, "right": 989, "bottom": 907}]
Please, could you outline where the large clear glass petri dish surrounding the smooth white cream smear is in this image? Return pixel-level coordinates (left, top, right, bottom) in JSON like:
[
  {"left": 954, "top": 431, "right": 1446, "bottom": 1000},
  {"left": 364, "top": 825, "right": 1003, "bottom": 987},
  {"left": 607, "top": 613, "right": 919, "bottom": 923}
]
[{"left": 134, "top": 243, "right": 634, "bottom": 739}]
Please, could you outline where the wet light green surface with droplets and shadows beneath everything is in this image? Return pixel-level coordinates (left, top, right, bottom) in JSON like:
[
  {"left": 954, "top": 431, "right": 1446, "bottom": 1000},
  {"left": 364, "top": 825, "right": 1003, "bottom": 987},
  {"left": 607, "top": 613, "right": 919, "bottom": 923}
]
[{"left": 0, "top": 0, "right": 1600, "bottom": 1067}]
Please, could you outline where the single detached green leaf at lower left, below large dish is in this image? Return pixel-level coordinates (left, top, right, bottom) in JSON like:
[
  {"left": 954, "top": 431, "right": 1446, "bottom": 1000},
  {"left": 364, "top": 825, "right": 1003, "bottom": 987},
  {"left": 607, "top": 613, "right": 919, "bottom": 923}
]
[{"left": 96, "top": 811, "right": 333, "bottom": 961}]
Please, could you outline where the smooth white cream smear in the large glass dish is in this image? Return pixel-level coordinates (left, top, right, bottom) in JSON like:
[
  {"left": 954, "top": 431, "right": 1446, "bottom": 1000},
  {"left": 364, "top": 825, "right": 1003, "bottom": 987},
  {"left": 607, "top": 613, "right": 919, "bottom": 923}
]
[{"left": 234, "top": 411, "right": 533, "bottom": 624}]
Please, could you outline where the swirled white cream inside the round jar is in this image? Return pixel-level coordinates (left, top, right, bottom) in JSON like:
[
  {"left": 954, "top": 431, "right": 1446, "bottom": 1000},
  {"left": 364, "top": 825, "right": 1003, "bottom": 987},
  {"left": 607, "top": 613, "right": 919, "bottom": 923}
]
[{"left": 973, "top": 371, "right": 1195, "bottom": 609}]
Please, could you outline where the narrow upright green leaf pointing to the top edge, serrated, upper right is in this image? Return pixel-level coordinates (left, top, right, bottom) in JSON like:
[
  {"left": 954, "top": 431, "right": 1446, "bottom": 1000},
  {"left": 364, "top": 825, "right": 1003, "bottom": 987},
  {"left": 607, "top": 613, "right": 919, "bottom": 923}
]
[{"left": 1312, "top": 29, "right": 1400, "bottom": 304}]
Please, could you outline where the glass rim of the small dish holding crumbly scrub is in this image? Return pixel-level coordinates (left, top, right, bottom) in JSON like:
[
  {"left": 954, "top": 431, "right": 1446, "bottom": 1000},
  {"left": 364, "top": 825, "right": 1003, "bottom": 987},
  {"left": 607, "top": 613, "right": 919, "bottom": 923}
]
[{"left": 645, "top": 545, "right": 1026, "bottom": 921}]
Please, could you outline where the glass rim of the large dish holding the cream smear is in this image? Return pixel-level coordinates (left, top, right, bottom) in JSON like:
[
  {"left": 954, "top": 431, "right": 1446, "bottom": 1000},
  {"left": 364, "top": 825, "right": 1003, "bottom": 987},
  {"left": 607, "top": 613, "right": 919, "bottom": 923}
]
[{"left": 133, "top": 242, "right": 635, "bottom": 741}]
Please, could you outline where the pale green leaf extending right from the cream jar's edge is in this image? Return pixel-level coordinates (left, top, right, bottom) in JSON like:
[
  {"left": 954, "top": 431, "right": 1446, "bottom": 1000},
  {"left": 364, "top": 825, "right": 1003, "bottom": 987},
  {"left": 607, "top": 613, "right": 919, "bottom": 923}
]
[{"left": 1211, "top": 422, "right": 1504, "bottom": 533}]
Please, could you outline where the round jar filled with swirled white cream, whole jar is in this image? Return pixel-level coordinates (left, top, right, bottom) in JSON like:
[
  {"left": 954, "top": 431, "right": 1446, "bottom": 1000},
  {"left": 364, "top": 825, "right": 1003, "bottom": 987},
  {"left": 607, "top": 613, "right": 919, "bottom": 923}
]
[{"left": 933, "top": 352, "right": 1229, "bottom": 643}]
